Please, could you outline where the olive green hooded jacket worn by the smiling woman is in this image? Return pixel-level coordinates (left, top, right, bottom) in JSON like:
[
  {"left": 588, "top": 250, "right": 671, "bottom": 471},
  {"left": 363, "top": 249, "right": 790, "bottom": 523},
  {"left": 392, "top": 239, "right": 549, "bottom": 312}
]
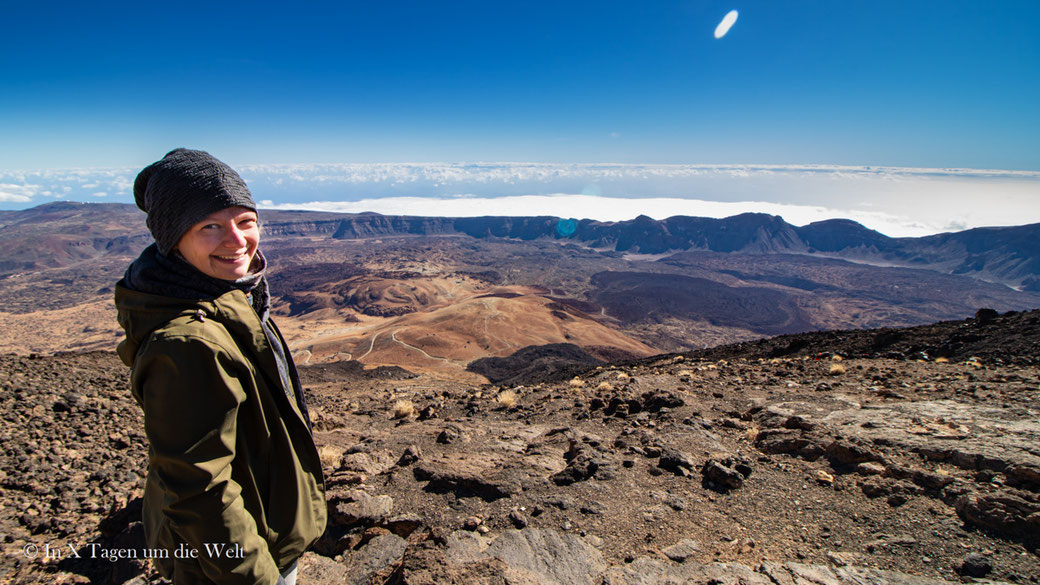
[{"left": 115, "top": 282, "right": 327, "bottom": 584}]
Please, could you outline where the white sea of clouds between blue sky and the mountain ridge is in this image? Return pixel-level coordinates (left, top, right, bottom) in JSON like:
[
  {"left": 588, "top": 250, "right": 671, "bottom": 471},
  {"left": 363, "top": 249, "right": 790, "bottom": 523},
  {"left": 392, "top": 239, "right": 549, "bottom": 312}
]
[{"left": 0, "top": 162, "right": 1040, "bottom": 236}]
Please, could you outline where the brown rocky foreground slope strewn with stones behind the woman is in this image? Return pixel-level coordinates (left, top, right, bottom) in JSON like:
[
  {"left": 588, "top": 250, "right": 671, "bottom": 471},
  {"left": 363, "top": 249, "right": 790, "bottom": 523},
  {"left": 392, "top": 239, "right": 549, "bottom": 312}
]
[{"left": 0, "top": 313, "right": 1040, "bottom": 585}]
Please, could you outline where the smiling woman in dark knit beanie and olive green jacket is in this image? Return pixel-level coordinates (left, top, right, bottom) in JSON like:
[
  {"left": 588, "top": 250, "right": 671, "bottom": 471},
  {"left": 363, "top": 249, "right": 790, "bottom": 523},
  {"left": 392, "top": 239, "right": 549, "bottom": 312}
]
[{"left": 115, "top": 149, "right": 326, "bottom": 585}]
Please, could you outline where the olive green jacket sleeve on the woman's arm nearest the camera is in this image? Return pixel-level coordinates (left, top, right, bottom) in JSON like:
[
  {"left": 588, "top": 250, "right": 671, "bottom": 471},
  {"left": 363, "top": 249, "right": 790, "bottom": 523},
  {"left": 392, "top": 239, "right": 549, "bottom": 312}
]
[{"left": 133, "top": 336, "right": 280, "bottom": 585}]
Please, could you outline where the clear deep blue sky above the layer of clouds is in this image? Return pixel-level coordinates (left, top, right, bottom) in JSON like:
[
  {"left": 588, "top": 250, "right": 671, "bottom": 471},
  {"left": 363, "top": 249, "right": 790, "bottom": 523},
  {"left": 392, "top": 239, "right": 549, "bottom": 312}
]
[{"left": 0, "top": 0, "right": 1040, "bottom": 234}]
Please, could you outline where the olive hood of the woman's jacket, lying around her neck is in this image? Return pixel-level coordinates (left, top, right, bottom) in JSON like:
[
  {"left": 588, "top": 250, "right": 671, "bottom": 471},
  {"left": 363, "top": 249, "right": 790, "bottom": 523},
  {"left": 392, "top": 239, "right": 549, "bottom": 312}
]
[{"left": 115, "top": 280, "right": 263, "bottom": 367}]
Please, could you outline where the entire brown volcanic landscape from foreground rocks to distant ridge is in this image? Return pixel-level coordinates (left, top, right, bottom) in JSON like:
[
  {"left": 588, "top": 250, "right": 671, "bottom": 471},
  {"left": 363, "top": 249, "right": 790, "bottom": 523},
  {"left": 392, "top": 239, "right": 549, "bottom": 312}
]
[{"left": 0, "top": 204, "right": 1040, "bottom": 585}]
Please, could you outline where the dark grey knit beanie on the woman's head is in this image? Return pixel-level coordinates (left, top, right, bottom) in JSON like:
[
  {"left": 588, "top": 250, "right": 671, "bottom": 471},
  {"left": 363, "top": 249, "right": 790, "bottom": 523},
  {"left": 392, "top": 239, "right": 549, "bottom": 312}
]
[{"left": 133, "top": 148, "right": 257, "bottom": 255}]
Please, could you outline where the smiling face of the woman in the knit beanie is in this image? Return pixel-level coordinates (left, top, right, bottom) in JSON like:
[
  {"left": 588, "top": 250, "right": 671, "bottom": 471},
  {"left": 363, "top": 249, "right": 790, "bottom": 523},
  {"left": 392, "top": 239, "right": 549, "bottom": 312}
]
[{"left": 176, "top": 207, "right": 260, "bottom": 280}]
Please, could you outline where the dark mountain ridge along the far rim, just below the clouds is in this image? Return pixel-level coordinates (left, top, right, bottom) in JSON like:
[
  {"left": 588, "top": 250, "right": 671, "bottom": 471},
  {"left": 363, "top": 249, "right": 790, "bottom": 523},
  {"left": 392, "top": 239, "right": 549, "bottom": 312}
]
[{"left": 8, "top": 202, "right": 1040, "bottom": 291}]
